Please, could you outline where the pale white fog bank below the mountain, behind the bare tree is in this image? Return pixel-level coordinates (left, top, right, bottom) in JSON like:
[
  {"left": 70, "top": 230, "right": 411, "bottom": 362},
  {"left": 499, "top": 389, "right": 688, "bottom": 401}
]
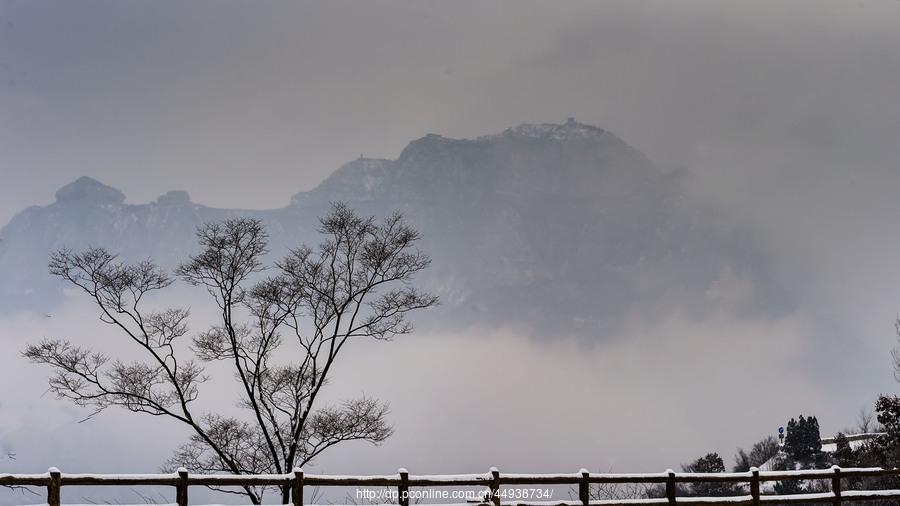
[{"left": 0, "top": 278, "right": 891, "bottom": 500}]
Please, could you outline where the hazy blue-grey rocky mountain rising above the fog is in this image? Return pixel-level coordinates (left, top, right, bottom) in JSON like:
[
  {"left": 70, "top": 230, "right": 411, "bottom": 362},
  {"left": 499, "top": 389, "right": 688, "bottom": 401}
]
[{"left": 0, "top": 119, "right": 784, "bottom": 333}]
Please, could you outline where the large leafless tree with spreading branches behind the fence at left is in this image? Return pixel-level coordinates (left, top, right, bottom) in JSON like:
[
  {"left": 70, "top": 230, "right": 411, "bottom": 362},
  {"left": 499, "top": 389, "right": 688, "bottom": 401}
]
[{"left": 24, "top": 204, "right": 437, "bottom": 504}]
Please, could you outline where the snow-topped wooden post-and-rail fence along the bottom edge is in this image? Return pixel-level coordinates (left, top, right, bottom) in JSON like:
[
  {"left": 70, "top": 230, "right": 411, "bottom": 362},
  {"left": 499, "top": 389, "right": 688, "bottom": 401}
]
[{"left": 0, "top": 466, "right": 900, "bottom": 506}]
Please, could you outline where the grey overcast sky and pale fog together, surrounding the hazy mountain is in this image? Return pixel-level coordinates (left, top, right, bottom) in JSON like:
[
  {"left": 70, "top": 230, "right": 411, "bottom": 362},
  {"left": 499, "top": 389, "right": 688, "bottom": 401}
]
[{"left": 0, "top": 0, "right": 900, "bottom": 498}]
